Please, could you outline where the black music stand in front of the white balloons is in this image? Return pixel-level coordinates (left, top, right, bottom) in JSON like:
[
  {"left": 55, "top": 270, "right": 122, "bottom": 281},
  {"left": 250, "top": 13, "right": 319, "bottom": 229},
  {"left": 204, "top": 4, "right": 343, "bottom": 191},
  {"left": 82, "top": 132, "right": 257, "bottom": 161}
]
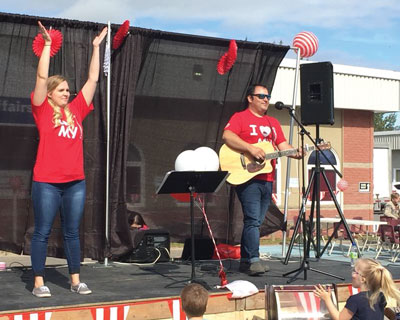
[{"left": 156, "top": 171, "right": 229, "bottom": 288}]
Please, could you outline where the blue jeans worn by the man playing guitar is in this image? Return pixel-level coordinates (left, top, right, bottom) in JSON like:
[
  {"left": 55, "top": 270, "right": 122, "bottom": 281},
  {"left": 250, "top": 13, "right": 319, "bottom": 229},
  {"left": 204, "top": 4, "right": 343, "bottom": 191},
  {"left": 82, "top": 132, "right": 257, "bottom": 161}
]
[{"left": 236, "top": 180, "right": 272, "bottom": 263}]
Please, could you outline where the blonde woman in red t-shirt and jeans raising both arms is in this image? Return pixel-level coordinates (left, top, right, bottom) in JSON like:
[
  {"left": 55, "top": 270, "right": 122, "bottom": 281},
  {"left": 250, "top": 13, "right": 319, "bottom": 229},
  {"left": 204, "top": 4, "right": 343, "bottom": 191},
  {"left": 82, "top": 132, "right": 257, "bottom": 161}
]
[{"left": 31, "top": 22, "right": 107, "bottom": 298}]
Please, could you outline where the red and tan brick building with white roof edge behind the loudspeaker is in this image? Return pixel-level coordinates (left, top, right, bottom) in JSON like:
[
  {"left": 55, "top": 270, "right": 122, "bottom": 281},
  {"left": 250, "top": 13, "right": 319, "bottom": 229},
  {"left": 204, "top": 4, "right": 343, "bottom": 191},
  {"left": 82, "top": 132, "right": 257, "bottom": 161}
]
[{"left": 269, "top": 59, "right": 400, "bottom": 220}]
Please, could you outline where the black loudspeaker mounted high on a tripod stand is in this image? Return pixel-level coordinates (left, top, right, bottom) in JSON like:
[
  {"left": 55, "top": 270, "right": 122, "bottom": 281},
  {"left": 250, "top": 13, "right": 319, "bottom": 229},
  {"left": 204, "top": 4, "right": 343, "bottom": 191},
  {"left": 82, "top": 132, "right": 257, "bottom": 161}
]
[{"left": 300, "top": 62, "right": 335, "bottom": 125}]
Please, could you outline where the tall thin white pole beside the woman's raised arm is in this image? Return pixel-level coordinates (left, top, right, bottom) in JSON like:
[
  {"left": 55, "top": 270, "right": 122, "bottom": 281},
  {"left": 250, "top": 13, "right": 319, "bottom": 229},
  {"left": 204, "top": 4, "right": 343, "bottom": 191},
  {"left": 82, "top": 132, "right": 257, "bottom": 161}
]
[{"left": 104, "top": 21, "right": 111, "bottom": 267}]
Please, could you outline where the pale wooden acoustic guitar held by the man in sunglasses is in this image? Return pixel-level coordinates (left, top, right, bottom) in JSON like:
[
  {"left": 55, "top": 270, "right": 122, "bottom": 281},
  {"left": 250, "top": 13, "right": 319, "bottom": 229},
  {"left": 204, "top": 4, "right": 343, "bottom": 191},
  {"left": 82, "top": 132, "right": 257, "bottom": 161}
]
[{"left": 219, "top": 141, "right": 331, "bottom": 185}]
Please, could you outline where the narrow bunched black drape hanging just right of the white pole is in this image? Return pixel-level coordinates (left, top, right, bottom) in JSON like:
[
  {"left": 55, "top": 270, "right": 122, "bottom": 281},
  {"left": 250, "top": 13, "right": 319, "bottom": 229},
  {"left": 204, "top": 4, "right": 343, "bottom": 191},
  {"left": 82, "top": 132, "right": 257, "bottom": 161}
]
[{"left": 107, "top": 29, "right": 153, "bottom": 256}]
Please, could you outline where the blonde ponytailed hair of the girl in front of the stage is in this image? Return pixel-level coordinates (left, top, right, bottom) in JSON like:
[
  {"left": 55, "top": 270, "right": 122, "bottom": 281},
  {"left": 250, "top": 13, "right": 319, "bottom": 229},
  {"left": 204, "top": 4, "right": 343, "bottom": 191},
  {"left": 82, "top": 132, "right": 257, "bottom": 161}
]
[{"left": 357, "top": 258, "right": 400, "bottom": 309}]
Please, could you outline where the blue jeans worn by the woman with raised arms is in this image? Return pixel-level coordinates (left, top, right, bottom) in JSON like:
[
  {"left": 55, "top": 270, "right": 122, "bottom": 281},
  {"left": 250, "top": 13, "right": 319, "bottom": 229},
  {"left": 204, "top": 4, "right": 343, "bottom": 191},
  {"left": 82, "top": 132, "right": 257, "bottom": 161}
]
[{"left": 31, "top": 180, "right": 86, "bottom": 276}]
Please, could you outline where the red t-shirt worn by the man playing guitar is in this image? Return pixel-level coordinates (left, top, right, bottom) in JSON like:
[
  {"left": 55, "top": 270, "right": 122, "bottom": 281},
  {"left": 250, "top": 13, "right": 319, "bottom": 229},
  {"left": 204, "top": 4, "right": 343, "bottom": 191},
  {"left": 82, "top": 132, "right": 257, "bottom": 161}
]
[{"left": 225, "top": 109, "right": 286, "bottom": 181}]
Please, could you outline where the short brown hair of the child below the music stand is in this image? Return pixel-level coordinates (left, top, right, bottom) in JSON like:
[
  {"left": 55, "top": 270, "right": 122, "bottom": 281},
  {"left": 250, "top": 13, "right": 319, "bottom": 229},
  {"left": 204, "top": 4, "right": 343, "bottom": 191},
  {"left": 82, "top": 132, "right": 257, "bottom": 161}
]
[{"left": 181, "top": 283, "right": 208, "bottom": 319}]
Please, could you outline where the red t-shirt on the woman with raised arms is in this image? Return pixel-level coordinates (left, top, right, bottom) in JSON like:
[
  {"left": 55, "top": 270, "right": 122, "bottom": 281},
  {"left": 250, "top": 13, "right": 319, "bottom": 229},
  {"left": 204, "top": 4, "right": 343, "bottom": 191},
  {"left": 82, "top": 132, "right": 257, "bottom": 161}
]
[{"left": 31, "top": 92, "right": 94, "bottom": 183}]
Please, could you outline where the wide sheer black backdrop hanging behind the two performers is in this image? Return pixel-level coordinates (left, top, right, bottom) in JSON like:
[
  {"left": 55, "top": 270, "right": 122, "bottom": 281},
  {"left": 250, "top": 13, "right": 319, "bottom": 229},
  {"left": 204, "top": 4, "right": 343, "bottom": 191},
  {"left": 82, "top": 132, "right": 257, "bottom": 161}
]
[{"left": 0, "top": 13, "right": 289, "bottom": 260}]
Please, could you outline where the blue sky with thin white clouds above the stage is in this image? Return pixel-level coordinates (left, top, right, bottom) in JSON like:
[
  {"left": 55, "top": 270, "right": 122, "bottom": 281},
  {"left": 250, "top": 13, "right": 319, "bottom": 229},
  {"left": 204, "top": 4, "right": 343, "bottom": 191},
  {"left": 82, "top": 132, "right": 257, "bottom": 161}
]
[{"left": 0, "top": 0, "right": 400, "bottom": 72}]
